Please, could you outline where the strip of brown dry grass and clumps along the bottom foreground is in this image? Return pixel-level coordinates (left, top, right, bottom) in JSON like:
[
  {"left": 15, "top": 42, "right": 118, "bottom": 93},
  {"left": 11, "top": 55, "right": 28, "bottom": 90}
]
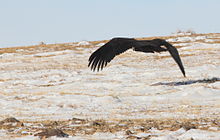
[{"left": 0, "top": 118, "right": 220, "bottom": 139}]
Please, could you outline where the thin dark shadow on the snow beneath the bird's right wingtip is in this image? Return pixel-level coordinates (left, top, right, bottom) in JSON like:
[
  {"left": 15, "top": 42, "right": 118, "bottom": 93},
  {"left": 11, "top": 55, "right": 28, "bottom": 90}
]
[{"left": 151, "top": 77, "right": 220, "bottom": 86}]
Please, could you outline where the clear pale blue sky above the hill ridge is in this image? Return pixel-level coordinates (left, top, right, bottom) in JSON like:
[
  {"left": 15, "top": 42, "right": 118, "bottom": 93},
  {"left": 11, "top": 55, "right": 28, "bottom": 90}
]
[{"left": 0, "top": 0, "right": 220, "bottom": 47}]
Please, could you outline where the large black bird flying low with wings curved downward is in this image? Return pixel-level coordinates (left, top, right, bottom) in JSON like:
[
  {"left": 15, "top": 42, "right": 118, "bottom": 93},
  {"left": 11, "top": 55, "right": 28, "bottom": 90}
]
[{"left": 88, "top": 38, "right": 186, "bottom": 77}]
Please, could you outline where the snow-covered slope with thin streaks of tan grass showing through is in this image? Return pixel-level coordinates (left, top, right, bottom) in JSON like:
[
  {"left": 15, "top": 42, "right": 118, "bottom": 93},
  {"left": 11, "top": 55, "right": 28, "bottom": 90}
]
[{"left": 0, "top": 34, "right": 220, "bottom": 140}]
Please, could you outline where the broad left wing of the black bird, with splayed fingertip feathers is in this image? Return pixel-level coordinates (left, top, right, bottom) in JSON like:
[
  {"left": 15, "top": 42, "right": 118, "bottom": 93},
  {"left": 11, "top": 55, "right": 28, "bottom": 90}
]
[{"left": 88, "top": 38, "right": 137, "bottom": 71}]
